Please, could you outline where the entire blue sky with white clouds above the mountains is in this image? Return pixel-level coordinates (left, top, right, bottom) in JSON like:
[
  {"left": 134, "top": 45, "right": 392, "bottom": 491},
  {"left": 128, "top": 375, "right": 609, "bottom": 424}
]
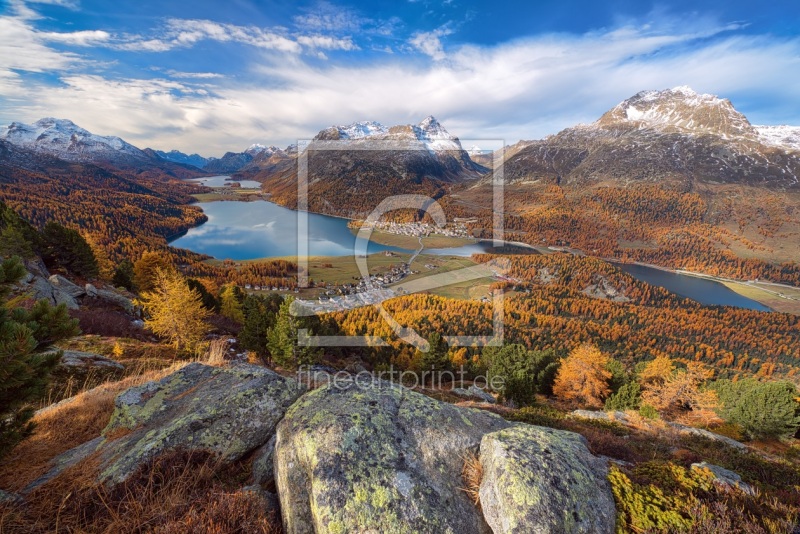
[{"left": 0, "top": 0, "right": 800, "bottom": 155}]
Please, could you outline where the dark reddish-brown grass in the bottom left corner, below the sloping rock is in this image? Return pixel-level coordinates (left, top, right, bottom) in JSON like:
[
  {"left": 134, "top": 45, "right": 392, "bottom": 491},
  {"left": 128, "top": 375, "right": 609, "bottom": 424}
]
[{"left": 0, "top": 451, "right": 280, "bottom": 534}]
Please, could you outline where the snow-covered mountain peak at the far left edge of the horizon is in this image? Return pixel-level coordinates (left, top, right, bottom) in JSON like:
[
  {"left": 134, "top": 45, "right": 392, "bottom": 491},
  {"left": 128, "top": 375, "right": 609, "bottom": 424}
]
[{"left": 0, "top": 117, "right": 149, "bottom": 161}]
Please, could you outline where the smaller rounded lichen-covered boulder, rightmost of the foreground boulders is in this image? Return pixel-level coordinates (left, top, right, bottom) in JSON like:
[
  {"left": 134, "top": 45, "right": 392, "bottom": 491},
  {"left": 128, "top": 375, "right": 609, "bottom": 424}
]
[{"left": 479, "top": 425, "right": 616, "bottom": 534}]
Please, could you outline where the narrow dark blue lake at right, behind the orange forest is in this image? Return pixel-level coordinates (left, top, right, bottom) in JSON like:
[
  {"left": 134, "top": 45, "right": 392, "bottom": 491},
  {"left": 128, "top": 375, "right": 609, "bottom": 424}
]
[{"left": 619, "top": 264, "right": 769, "bottom": 311}]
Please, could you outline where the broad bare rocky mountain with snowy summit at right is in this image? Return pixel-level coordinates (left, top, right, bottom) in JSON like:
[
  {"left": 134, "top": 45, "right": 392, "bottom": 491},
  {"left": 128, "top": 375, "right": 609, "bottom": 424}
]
[{"left": 504, "top": 87, "right": 800, "bottom": 190}]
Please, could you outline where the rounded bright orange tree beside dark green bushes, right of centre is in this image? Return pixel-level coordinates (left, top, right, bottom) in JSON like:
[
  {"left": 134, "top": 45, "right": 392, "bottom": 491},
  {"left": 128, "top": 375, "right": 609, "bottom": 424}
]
[{"left": 553, "top": 344, "right": 611, "bottom": 407}]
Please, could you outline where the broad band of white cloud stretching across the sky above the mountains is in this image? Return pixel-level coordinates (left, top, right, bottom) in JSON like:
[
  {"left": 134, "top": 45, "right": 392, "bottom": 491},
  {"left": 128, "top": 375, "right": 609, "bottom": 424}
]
[{"left": 0, "top": 14, "right": 800, "bottom": 156}]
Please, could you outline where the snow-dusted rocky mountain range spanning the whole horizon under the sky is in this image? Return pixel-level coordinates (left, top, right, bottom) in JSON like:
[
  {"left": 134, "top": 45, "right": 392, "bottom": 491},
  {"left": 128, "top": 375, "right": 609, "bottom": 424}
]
[{"left": 0, "top": 87, "right": 800, "bottom": 194}]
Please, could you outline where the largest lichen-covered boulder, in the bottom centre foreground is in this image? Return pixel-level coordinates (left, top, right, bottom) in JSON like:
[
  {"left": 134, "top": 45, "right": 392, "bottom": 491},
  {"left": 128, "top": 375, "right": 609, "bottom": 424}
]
[{"left": 274, "top": 380, "right": 510, "bottom": 534}]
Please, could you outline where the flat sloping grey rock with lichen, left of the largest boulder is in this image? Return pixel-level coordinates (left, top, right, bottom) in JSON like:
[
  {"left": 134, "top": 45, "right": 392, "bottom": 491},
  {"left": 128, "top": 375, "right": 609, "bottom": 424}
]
[{"left": 32, "top": 363, "right": 304, "bottom": 492}]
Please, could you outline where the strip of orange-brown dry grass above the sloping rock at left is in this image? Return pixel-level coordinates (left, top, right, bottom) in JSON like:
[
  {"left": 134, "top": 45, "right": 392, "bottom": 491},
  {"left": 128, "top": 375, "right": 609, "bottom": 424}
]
[{"left": 0, "top": 362, "right": 186, "bottom": 491}]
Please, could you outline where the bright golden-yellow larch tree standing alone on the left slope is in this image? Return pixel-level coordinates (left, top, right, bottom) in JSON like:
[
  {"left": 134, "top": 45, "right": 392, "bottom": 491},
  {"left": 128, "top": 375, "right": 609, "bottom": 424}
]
[{"left": 136, "top": 268, "right": 211, "bottom": 352}]
